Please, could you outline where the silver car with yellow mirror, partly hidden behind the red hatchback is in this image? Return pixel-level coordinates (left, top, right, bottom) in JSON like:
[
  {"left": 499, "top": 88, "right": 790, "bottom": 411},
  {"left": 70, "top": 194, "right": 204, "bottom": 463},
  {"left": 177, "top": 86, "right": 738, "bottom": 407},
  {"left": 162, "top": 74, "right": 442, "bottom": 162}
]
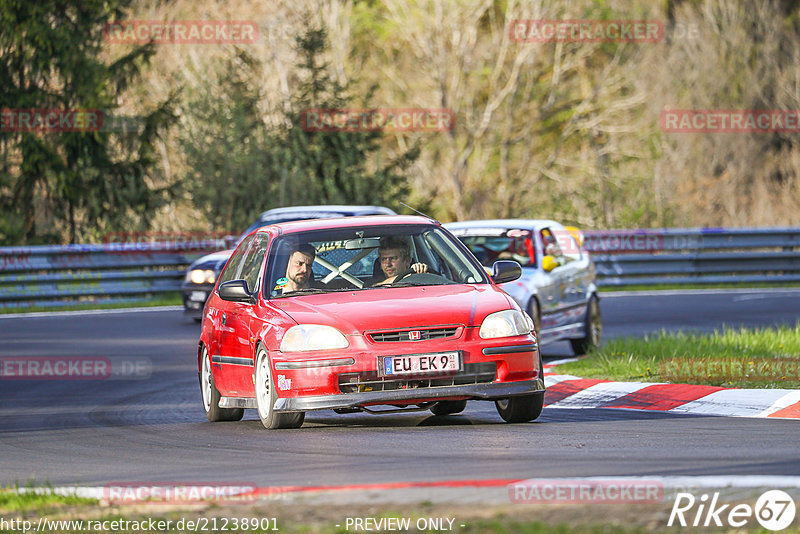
[{"left": 444, "top": 219, "right": 603, "bottom": 354}]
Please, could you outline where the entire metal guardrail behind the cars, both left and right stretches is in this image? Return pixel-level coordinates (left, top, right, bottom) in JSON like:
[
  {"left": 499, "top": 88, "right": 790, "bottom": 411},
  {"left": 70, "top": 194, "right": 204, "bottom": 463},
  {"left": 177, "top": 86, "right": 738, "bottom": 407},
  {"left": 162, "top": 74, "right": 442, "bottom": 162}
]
[{"left": 0, "top": 228, "right": 800, "bottom": 308}]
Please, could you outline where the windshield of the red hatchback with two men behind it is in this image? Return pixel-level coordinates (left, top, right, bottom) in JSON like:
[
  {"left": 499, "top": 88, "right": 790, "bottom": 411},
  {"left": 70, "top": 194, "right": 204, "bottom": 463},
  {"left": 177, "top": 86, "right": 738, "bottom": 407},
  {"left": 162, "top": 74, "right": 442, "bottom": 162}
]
[{"left": 264, "top": 225, "right": 488, "bottom": 298}]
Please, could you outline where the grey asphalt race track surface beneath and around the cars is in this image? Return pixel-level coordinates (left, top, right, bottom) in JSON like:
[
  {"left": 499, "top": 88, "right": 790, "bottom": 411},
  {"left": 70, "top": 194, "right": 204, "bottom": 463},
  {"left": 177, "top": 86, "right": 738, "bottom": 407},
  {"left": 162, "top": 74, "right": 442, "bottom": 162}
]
[{"left": 0, "top": 290, "right": 800, "bottom": 486}]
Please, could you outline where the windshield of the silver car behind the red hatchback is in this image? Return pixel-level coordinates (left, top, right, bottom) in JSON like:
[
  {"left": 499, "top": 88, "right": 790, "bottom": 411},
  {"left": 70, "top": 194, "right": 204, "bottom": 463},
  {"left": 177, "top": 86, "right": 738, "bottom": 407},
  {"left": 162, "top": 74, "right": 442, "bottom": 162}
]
[{"left": 456, "top": 228, "right": 536, "bottom": 267}]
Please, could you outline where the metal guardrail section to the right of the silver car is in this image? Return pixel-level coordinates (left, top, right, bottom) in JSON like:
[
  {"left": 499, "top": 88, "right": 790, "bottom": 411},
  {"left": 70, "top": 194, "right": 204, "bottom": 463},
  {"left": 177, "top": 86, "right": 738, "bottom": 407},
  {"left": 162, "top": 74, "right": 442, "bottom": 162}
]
[{"left": 584, "top": 228, "right": 800, "bottom": 287}]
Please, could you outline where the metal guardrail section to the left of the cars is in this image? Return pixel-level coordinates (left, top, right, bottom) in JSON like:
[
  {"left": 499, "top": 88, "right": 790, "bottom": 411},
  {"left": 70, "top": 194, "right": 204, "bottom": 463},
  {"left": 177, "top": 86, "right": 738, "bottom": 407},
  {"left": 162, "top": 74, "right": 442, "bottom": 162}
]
[{"left": 0, "top": 239, "right": 225, "bottom": 308}]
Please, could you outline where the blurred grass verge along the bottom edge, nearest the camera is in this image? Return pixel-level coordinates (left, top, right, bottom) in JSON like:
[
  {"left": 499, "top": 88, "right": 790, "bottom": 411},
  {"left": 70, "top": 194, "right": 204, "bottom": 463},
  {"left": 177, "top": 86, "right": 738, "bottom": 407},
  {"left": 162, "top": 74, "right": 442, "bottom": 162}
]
[{"left": 0, "top": 485, "right": 800, "bottom": 534}]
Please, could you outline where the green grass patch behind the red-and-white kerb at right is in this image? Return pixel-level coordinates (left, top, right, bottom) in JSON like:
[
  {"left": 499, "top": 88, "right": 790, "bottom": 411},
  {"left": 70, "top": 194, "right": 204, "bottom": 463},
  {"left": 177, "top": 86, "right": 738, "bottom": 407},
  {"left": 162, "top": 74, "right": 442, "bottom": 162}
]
[{"left": 558, "top": 324, "right": 800, "bottom": 389}]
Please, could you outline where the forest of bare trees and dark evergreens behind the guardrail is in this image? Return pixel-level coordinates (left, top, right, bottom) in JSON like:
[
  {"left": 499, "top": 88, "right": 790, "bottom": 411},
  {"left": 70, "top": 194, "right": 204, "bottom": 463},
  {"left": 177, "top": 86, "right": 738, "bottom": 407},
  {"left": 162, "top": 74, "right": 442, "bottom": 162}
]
[{"left": 0, "top": 0, "right": 800, "bottom": 245}]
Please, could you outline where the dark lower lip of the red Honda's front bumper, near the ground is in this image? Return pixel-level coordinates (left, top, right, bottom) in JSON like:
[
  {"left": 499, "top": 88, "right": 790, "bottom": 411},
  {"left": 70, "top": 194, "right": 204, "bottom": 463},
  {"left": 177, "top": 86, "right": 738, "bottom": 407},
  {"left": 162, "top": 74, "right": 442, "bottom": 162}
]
[{"left": 274, "top": 375, "right": 545, "bottom": 412}]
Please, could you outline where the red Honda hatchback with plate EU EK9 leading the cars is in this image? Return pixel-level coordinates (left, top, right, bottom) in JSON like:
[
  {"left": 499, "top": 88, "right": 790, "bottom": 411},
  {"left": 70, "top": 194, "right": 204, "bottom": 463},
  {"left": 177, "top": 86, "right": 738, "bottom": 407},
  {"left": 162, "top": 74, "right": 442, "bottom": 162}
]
[{"left": 197, "top": 216, "right": 545, "bottom": 428}]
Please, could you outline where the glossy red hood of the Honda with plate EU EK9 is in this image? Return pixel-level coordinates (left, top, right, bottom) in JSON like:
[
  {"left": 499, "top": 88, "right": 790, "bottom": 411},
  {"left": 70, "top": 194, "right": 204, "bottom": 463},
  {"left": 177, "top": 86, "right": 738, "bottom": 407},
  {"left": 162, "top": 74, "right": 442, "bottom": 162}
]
[{"left": 271, "top": 284, "right": 514, "bottom": 335}]
